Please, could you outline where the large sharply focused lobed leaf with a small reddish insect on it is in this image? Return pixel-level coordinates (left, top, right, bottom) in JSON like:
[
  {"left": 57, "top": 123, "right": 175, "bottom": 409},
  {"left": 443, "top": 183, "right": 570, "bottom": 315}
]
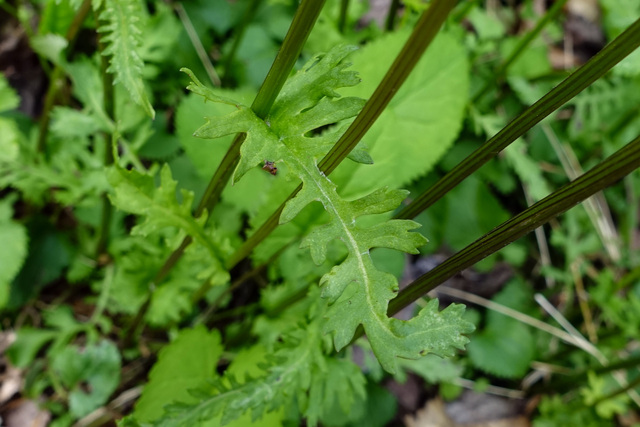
[{"left": 182, "top": 46, "right": 473, "bottom": 373}]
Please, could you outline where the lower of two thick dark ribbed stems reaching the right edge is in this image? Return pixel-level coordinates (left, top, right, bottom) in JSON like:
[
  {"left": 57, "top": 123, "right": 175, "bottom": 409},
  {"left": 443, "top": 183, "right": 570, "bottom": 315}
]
[{"left": 388, "top": 136, "right": 640, "bottom": 315}]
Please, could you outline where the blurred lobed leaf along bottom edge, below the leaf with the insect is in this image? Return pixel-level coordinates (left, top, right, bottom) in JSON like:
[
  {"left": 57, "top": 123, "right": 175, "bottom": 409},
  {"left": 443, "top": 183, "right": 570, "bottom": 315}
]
[{"left": 152, "top": 319, "right": 366, "bottom": 427}]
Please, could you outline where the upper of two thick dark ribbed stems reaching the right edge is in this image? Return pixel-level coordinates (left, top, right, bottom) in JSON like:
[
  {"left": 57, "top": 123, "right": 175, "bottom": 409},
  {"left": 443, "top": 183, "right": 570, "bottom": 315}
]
[{"left": 395, "top": 19, "right": 640, "bottom": 219}]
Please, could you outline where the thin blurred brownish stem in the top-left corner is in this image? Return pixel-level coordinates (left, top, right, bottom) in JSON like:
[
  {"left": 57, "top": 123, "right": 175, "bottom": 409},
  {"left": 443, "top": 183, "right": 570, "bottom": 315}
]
[{"left": 37, "top": 0, "right": 91, "bottom": 153}]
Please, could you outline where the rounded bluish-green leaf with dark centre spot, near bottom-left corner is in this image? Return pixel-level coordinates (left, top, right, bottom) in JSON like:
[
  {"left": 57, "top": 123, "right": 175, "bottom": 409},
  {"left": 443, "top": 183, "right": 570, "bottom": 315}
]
[{"left": 51, "top": 340, "right": 120, "bottom": 418}]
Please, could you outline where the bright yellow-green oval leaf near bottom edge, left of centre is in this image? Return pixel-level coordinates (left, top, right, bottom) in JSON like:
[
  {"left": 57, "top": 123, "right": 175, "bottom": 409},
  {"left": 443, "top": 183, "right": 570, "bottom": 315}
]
[{"left": 134, "top": 326, "right": 223, "bottom": 422}]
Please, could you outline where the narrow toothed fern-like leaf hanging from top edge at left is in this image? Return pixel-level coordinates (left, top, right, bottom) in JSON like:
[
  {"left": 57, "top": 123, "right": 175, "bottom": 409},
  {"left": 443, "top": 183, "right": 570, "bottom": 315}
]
[{"left": 98, "top": 0, "right": 156, "bottom": 118}]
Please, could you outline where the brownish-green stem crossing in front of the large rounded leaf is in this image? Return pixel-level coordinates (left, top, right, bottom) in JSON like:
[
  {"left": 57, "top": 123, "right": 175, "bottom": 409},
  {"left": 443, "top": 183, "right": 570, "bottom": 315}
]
[{"left": 227, "top": 0, "right": 455, "bottom": 268}]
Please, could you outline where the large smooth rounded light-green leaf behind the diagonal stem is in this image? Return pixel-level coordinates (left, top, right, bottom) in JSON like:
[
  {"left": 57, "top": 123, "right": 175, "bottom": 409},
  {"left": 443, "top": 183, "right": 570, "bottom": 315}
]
[{"left": 331, "top": 31, "right": 469, "bottom": 195}]
